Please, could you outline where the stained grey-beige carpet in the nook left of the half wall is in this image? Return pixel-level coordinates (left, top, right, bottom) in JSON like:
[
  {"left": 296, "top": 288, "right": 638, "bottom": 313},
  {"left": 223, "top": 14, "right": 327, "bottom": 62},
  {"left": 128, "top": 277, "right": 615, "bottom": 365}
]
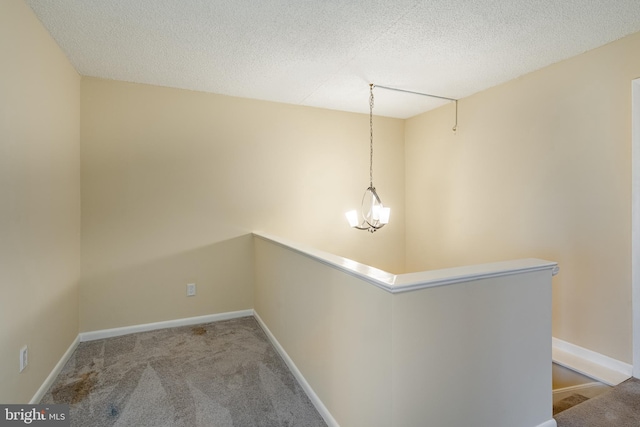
[{"left": 41, "top": 317, "right": 326, "bottom": 427}]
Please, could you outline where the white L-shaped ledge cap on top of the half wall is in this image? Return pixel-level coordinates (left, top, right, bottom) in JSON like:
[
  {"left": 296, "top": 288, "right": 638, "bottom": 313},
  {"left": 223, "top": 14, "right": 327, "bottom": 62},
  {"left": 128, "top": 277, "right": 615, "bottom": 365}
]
[{"left": 253, "top": 232, "right": 560, "bottom": 293}]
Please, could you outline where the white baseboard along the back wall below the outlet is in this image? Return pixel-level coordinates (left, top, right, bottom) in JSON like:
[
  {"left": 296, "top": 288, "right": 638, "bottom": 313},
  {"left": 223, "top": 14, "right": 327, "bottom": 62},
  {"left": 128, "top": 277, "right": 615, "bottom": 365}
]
[{"left": 79, "top": 309, "right": 253, "bottom": 342}]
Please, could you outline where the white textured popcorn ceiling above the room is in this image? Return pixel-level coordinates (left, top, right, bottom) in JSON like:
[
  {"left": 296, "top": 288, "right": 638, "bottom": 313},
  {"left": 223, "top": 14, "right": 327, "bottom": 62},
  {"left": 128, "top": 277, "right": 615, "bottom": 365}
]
[{"left": 27, "top": 0, "right": 640, "bottom": 118}]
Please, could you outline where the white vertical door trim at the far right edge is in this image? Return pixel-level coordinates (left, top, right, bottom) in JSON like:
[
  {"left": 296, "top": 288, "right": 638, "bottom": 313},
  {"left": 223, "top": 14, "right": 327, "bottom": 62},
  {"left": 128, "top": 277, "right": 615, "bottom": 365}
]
[{"left": 631, "top": 79, "right": 640, "bottom": 378}]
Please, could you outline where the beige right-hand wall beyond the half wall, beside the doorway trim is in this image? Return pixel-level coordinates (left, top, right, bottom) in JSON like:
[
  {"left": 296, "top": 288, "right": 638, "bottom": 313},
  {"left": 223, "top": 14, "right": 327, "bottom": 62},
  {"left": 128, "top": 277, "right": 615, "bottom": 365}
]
[{"left": 405, "top": 33, "right": 640, "bottom": 363}]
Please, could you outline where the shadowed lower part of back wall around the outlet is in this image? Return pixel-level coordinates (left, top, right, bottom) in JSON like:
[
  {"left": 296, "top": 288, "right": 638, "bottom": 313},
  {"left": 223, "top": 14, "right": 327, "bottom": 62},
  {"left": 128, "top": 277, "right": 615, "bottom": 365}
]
[{"left": 80, "top": 234, "right": 254, "bottom": 332}]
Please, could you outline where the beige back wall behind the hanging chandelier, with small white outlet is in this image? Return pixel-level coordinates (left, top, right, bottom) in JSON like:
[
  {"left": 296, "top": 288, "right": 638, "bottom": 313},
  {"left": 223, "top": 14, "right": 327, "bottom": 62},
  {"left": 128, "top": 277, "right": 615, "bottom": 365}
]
[{"left": 80, "top": 78, "right": 404, "bottom": 331}]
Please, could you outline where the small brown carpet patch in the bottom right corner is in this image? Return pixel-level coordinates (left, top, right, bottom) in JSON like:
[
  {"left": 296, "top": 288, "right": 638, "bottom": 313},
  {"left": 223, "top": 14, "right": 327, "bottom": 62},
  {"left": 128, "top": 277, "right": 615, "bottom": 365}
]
[{"left": 555, "top": 378, "right": 640, "bottom": 427}]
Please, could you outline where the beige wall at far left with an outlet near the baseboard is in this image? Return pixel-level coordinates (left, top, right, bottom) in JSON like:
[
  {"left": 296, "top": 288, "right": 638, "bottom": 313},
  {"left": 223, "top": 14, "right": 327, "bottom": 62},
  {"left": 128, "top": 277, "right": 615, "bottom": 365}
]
[{"left": 0, "top": 1, "right": 80, "bottom": 403}]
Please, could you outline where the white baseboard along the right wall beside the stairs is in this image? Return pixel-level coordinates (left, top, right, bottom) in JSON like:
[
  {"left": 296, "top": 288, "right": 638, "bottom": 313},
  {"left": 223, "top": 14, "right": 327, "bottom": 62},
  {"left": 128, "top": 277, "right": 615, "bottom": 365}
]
[{"left": 552, "top": 338, "right": 633, "bottom": 386}]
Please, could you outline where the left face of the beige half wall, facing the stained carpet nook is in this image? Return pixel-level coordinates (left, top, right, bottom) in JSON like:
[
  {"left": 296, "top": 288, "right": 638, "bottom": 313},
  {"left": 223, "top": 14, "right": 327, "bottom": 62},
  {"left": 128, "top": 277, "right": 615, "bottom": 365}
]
[{"left": 255, "top": 237, "right": 393, "bottom": 427}]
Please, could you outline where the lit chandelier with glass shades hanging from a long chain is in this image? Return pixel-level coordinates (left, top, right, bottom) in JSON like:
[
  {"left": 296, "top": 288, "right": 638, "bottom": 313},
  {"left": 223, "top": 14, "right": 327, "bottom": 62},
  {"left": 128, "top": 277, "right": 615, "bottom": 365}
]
[{"left": 345, "top": 83, "right": 391, "bottom": 233}]
